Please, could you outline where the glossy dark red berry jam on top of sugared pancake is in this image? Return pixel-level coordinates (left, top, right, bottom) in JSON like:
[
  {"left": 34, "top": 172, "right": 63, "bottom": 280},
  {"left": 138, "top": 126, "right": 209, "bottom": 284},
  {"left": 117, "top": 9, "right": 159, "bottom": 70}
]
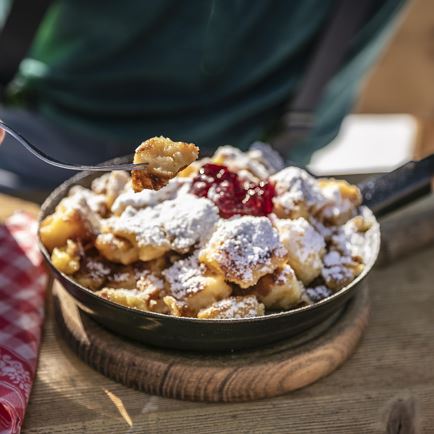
[{"left": 191, "top": 163, "right": 275, "bottom": 218}]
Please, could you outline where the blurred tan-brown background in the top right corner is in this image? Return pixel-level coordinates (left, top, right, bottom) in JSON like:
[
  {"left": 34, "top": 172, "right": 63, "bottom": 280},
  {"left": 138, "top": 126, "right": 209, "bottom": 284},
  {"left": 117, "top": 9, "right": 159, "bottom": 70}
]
[{"left": 355, "top": 0, "right": 434, "bottom": 127}]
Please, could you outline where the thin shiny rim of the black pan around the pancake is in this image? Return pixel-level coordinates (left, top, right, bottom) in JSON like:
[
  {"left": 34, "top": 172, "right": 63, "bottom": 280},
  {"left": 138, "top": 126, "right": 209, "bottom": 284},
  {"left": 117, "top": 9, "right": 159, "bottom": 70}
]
[{"left": 37, "top": 156, "right": 381, "bottom": 324}]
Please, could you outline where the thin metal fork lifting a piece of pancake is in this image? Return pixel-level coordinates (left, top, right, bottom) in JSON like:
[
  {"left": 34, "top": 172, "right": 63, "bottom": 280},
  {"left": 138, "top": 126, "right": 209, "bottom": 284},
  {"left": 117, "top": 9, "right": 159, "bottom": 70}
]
[{"left": 0, "top": 120, "right": 148, "bottom": 172}]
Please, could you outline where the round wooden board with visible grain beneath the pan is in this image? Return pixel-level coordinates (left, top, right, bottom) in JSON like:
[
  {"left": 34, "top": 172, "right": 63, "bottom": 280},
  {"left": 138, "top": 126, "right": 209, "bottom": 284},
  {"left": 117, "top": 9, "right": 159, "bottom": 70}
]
[{"left": 53, "top": 283, "right": 369, "bottom": 402}]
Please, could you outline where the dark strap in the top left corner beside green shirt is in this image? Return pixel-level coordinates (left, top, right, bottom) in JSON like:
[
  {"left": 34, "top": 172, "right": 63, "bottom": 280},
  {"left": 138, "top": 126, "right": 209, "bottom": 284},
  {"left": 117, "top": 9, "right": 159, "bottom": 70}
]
[{"left": 0, "top": 0, "right": 52, "bottom": 93}]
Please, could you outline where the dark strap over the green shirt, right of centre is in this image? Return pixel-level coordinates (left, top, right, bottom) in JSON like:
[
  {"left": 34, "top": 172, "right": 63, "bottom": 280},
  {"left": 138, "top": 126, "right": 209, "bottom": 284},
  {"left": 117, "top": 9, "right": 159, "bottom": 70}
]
[{"left": 271, "top": 0, "right": 376, "bottom": 154}]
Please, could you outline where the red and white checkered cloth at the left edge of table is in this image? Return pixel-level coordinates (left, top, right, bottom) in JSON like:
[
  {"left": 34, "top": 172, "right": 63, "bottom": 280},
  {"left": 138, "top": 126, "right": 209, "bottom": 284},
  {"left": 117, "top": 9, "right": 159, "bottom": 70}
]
[{"left": 0, "top": 212, "right": 48, "bottom": 434}]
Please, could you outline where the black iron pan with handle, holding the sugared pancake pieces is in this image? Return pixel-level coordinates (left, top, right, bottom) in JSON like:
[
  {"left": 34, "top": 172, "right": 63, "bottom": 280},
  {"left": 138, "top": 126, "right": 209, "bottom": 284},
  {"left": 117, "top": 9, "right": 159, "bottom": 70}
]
[{"left": 39, "top": 155, "right": 434, "bottom": 351}]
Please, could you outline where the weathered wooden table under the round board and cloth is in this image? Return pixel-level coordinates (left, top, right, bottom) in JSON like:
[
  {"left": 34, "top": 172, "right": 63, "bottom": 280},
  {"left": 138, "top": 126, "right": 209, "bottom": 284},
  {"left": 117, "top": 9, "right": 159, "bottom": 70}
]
[{"left": 0, "top": 196, "right": 434, "bottom": 434}]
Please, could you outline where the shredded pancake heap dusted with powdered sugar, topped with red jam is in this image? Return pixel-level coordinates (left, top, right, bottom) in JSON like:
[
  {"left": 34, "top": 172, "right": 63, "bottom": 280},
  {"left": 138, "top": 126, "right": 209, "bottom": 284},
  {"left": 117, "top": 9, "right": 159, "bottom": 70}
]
[{"left": 40, "top": 137, "right": 375, "bottom": 320}]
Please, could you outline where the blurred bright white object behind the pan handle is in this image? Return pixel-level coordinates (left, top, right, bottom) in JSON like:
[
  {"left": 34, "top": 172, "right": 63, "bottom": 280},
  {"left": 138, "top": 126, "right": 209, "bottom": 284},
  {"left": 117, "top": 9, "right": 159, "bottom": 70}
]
[{"left": 308, "top": 114, "right": 417, "bottom": 175}]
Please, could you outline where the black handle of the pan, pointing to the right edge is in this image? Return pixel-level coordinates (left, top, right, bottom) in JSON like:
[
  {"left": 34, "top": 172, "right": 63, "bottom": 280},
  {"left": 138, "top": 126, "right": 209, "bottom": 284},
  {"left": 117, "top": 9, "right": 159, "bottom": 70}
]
[{"left": 359, "top": 154, "right": 434, "bottom": 217}]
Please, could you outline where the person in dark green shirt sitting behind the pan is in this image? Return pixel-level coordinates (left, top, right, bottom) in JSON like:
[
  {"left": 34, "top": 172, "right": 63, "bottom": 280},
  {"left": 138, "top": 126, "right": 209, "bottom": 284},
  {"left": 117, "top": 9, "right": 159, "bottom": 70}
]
[{"left": 0, "top": 0, "right": 404, "bottom": 190}]
